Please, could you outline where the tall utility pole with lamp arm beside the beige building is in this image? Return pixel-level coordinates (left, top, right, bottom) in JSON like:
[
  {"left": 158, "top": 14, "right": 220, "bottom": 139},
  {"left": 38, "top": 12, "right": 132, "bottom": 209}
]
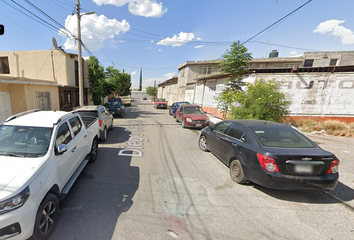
[{"left": 76, "top": 0, "right": 95, "bottom": 106}]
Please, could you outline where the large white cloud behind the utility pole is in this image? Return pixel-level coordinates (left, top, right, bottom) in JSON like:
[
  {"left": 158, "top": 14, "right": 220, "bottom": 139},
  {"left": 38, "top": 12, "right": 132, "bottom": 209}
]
[{"left": 59, "top": 14, "right": 130, "bottom": 51}]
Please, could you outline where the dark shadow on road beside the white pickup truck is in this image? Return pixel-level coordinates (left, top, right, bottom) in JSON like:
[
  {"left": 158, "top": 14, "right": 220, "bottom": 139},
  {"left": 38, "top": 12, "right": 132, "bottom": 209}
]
[{"left": 51, "top": 127, "right": 140, "bottom": 240}]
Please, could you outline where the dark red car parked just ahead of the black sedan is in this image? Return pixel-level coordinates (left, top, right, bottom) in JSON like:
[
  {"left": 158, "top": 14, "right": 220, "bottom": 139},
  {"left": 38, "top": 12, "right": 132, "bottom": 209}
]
[{"left": 176, "top": 105, "right": 210, "bottom": 128}]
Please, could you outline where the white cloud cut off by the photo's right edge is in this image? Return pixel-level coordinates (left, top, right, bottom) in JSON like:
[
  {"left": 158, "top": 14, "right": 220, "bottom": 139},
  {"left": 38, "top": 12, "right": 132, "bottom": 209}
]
[{"left": 313, "top": 19, "right": 354, "bottom": 44}]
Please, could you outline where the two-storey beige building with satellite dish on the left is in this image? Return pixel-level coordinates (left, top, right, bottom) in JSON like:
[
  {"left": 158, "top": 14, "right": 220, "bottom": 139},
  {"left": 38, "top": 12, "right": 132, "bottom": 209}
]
[{"left": 0, "top": 49, "right": 92, "bottom": 122}]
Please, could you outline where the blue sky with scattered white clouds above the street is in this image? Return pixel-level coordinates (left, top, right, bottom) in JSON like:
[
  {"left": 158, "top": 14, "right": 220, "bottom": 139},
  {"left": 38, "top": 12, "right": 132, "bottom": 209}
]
[{"left": 0, "top": 0, "right": 354, "bottom": 87}]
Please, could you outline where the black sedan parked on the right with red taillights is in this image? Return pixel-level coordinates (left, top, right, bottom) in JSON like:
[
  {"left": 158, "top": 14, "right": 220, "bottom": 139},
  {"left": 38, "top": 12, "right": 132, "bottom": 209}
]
[{"left": 199, "top": 120, "right": 339, "bottom": 191}]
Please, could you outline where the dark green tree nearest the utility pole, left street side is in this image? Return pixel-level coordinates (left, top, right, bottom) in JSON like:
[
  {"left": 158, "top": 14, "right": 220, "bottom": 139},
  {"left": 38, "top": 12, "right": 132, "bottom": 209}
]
[{"left": 88, "top": 56, "right": 105, "bottom": 105}]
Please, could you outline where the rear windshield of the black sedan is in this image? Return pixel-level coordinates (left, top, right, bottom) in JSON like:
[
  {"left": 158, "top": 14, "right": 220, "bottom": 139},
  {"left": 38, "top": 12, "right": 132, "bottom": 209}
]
[{"left": 250, "top": 124, "right": 317, "bottom": 148}]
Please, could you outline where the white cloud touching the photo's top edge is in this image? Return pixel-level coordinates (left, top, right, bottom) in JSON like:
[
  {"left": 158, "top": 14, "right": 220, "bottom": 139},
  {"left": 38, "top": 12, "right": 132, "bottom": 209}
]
[{"left": 93, "top": 0, "right": 167, "bottom": 17}]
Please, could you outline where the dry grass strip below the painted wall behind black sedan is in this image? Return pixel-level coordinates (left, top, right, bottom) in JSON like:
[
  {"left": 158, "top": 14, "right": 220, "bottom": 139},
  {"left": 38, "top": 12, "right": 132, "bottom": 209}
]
[{"left": 294, "top": 120, "right": 354, "bottom": 137}]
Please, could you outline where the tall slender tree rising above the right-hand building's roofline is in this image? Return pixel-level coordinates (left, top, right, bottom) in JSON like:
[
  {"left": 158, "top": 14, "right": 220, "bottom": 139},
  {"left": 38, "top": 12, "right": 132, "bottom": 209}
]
[{"left": 216, "top": 42, "right": 252, "bottom": 117}]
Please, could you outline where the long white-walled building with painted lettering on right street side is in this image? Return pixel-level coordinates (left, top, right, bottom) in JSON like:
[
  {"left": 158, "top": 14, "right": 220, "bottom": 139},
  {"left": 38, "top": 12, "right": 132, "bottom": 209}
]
[{"left": 158, "top": 51, "right": 354, "bottom": 122}]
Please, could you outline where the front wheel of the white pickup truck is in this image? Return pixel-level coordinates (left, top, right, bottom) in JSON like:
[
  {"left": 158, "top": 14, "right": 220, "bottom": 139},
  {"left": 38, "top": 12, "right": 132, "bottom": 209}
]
[{"left": 32, "top": 193, "right": 59, "bottom": 240}]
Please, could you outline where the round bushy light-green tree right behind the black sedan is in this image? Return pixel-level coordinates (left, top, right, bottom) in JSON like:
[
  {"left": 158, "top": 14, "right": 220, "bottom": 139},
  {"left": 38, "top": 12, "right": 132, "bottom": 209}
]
[{"left": 229, "top": 79, "right": 291, "bottom": 122}]
